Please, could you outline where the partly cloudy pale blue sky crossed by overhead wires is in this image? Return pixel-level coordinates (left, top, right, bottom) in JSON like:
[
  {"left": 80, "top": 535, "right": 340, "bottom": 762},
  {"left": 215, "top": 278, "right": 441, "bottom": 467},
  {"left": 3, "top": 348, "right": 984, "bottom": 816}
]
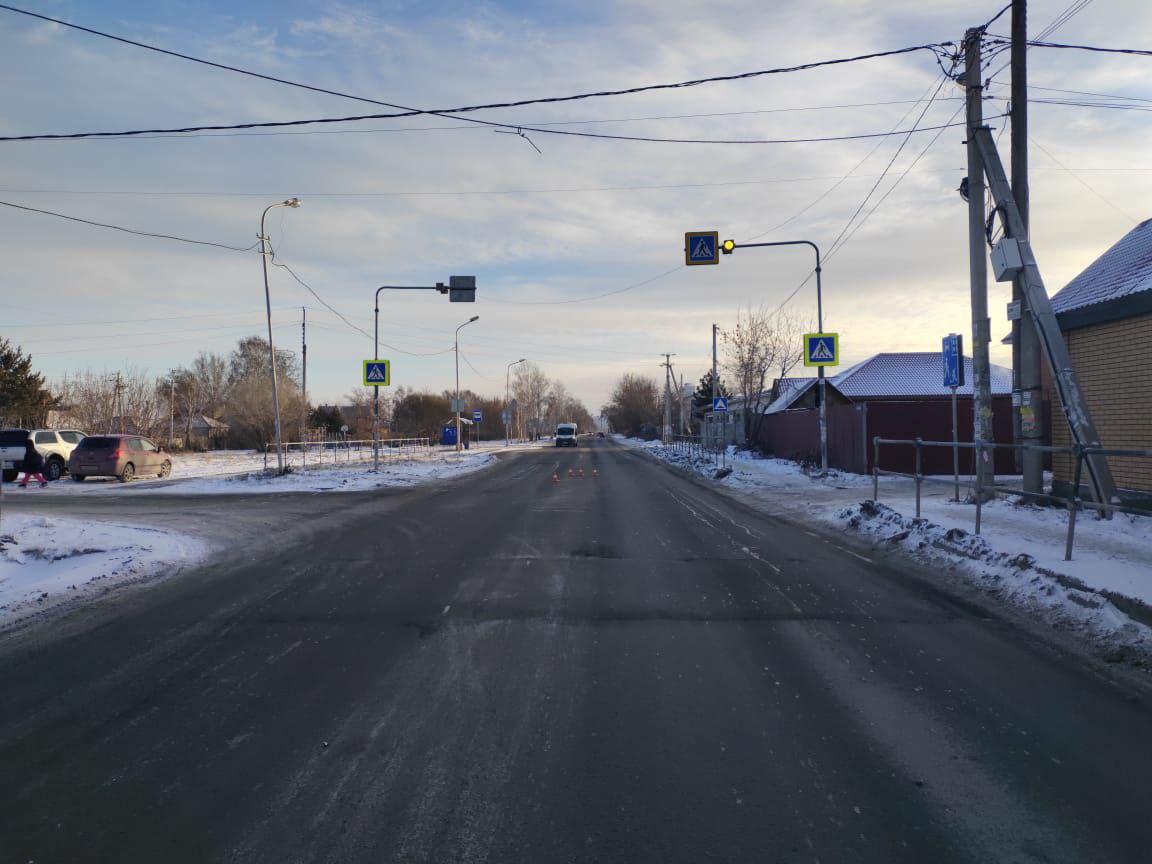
[{"left": 0, "top": 0, "right": 1152, "bottom": 414}]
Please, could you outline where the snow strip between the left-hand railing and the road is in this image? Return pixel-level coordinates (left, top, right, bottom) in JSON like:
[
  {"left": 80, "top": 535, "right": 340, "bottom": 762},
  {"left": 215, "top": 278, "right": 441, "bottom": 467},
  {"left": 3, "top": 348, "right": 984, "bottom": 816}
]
[{"left": 151, "top": 452, "right": 495, "bottom": 495}]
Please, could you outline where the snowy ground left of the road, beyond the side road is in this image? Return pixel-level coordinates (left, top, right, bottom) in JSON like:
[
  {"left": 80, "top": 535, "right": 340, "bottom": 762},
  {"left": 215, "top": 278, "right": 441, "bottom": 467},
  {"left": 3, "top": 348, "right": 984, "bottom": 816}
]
[{"left": 5, "top": 442, "right": 541, "bottom": 500}]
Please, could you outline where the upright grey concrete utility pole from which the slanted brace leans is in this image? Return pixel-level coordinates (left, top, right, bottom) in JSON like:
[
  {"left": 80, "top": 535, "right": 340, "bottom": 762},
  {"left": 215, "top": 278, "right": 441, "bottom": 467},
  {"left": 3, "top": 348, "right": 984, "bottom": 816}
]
[{"left": 964, "top": 28, "right": 995, "bottom": 498}]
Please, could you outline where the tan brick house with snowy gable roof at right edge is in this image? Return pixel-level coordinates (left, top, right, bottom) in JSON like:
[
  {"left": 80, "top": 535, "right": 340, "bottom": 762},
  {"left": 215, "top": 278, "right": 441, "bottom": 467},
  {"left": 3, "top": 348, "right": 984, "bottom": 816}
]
[{"left": 1048, "top": 219, "right": 1152, "bottom": 498}]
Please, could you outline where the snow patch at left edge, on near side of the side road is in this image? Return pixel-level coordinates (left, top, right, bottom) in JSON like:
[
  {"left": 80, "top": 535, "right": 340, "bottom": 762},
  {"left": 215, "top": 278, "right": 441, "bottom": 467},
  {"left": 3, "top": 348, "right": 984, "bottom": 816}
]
[{"left": 0, "top": 514, "right": 206, "bottom": 627}]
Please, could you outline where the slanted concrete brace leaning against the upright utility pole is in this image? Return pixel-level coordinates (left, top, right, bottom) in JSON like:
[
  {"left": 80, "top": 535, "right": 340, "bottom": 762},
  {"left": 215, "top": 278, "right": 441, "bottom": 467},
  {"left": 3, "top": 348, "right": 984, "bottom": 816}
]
[{"left": 972, "top": 126, "right": 1119, "bottom": 503}]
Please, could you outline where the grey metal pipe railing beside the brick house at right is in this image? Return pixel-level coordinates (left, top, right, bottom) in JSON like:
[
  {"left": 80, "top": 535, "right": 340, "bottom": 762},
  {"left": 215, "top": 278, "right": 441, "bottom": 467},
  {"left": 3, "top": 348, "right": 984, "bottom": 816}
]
[{"left": 872, "top": 437, "right": 1152, "bottom": 561}]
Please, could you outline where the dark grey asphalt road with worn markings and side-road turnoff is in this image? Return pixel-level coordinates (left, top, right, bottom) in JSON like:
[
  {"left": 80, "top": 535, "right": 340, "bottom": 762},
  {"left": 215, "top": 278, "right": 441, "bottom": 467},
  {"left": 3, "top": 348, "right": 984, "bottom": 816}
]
[{"left": 0, "top": 442, "right": 1152, "bottom": 864}]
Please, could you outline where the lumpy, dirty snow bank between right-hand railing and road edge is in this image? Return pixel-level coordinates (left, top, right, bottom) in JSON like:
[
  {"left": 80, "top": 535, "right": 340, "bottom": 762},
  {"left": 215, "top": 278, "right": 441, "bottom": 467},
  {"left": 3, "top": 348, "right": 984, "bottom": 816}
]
[{"left": 835, "top": 501, "right": 1152, "bottom": 659}]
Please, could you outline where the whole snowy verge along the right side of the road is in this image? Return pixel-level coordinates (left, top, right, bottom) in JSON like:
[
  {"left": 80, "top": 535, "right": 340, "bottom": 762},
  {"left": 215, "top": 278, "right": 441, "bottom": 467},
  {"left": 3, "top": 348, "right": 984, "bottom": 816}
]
[{"left": 620, "top": 439, "right": 1152, "bottom": 658}]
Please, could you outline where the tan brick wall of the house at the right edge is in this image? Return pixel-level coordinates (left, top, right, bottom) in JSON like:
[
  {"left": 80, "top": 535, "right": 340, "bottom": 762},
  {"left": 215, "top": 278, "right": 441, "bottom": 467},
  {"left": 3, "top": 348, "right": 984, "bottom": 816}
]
[{"left": 1049, "top": 314, "right": 1152, "bottom": 492}]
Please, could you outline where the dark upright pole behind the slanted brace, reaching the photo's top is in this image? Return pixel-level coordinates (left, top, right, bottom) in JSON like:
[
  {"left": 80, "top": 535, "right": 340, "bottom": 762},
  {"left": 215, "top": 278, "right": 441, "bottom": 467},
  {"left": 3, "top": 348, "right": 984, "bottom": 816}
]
[{"left": 1011, "top": 0, "right": 1048, "bottom": 494}]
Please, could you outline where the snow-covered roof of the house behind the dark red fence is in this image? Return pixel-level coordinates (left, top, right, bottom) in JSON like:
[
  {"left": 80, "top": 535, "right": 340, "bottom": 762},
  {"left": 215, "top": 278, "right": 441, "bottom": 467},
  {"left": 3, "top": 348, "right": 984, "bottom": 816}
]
[{"left": 831, "top": 351, "right": 1011, "bottom": 400}]
